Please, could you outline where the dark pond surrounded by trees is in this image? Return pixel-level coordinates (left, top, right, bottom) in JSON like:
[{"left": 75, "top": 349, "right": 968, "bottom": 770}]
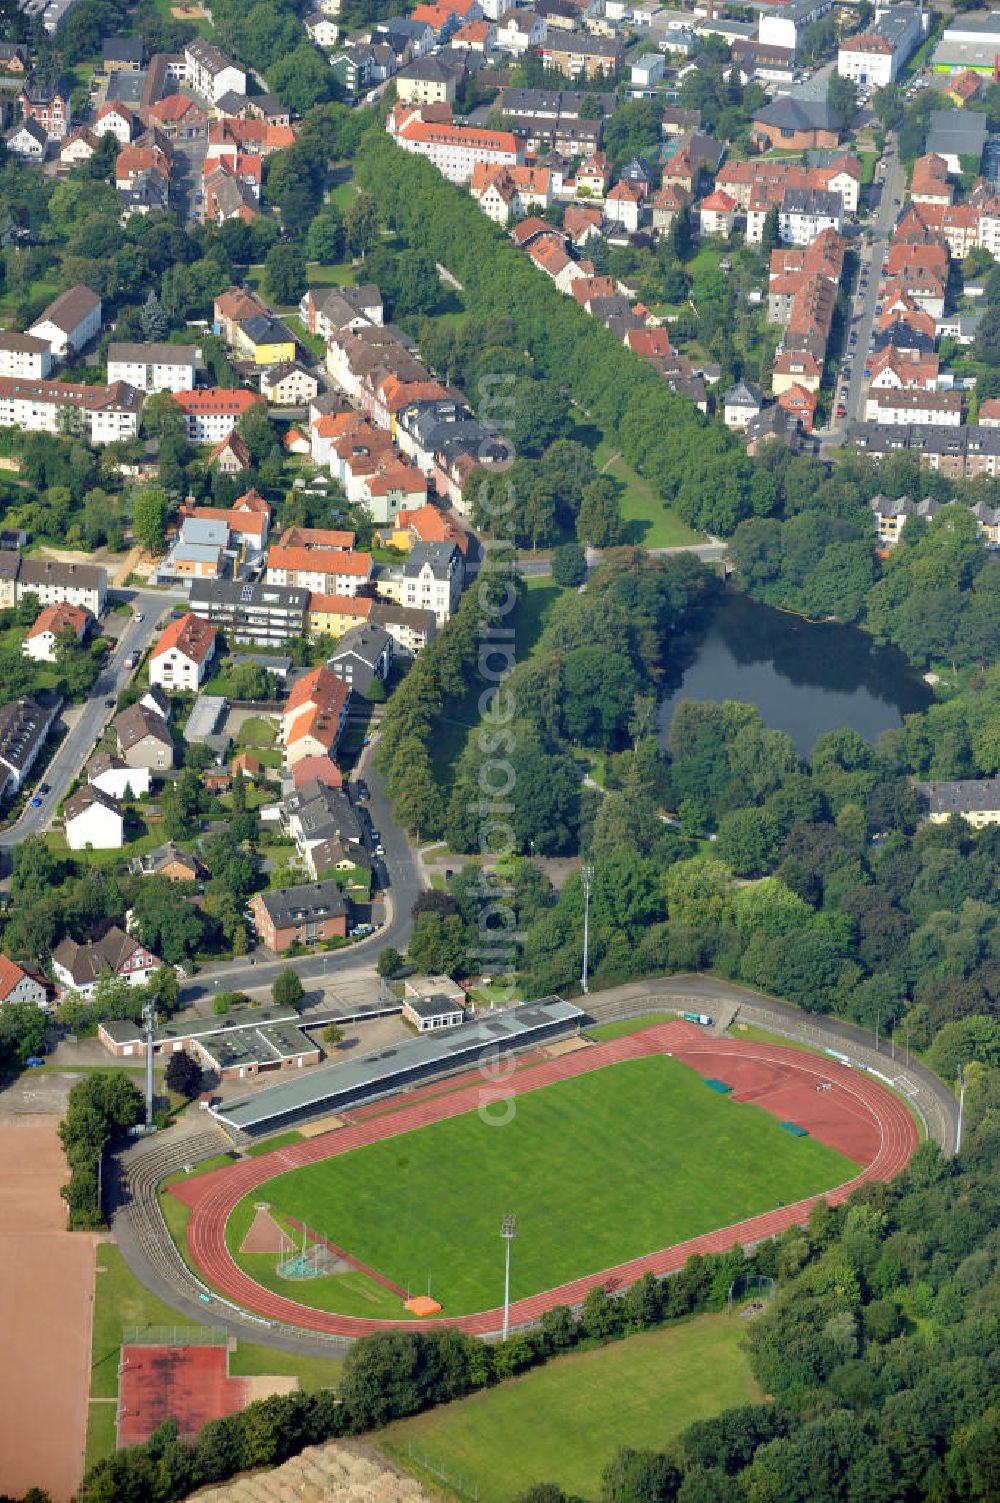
[{"left": 659, "top": 592, "right": 932, "bottom": 756}]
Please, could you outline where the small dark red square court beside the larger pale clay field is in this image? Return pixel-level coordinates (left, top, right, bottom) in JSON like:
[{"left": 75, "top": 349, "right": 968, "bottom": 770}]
[{"left": 117, "top": 1347, "right": 253, "bottom": 1446}]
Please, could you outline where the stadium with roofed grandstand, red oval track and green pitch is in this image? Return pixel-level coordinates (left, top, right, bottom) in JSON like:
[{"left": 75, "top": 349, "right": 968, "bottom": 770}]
[{"left": 170, "top": 998, "right": 919, "bottom": 1338}]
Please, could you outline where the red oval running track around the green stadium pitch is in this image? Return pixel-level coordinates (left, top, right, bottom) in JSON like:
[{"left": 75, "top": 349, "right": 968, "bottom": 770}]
[{"left": 170, "top": 1022, "right": 917, "bottom": 1338}]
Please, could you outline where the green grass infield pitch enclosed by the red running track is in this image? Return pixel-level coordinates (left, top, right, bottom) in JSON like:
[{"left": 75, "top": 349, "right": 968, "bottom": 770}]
[{"left": 227, "top": 1055, "right": 857, "bottom": 1318}]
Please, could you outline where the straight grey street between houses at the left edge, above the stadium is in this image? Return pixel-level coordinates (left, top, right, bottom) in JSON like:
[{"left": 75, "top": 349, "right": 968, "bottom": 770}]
[{"left": 0, "top": 589, "right": 171, "bottom": 849}]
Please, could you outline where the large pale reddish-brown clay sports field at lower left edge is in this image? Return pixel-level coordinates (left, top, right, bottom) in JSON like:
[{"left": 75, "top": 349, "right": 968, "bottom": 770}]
[{"left": 0, "top": 1117, "right": 95, "bottom": 1503}]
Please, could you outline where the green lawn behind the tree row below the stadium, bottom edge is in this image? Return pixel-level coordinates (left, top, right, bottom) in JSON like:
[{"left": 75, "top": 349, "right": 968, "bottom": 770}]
[{"left": 379, "top": 1315, "right": 761, "bottom": 1503}]
